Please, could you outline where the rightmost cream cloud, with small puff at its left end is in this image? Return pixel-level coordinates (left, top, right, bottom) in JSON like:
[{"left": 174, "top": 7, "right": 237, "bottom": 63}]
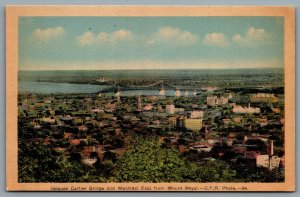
[{"left": 232, "top": 27, "right": 271, "bottom": 46}]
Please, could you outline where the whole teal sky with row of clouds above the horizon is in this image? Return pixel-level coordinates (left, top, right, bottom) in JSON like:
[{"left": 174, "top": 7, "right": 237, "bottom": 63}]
[{"left": 18, "top": 16, "right": 284, "bottom": 70}]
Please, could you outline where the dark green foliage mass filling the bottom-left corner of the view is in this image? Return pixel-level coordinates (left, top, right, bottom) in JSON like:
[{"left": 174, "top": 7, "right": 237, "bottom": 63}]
[{"left": 18, "top": 142, "right": 86, "bottom": 182}]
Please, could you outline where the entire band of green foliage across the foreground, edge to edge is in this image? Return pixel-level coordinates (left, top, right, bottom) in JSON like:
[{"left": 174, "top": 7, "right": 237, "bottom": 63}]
[{"left": 18, "top": 138, "right": 284, "bottom": 182}]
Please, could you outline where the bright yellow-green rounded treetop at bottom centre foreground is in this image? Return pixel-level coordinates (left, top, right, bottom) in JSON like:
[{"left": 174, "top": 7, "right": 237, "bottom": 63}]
[{"left": 115, "top": 139, "right": 187, "bottom": 182}]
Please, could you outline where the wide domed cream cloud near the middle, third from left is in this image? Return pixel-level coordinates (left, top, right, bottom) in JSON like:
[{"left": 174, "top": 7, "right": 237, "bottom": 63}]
[{"left": 147, "top": 26, "right": 199, "bottom": 46}]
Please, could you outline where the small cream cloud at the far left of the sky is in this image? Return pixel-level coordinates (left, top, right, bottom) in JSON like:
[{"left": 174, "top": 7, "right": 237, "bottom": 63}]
[{"left": 33, "top": 26, "right": 65, "bottom": 42}]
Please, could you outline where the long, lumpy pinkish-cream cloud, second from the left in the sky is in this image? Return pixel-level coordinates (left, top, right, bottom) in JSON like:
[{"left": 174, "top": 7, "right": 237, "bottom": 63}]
[{"left": 76, "top": 29, "right": 135, "bottom": 46}]
